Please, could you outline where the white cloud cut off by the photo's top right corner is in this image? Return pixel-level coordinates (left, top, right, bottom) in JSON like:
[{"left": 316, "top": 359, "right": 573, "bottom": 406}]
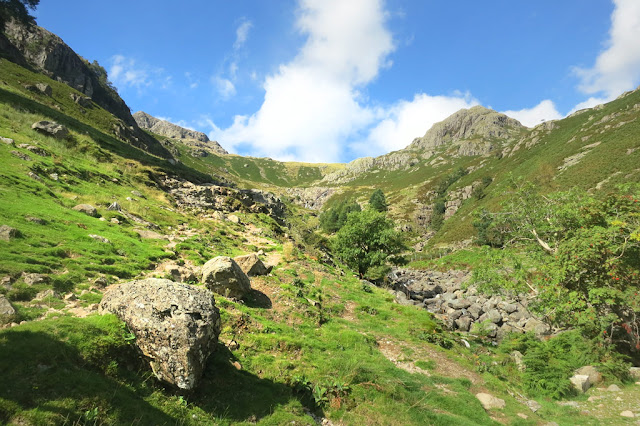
[{"left": 574, "top": 0, "right": 640, "bottom": 100}]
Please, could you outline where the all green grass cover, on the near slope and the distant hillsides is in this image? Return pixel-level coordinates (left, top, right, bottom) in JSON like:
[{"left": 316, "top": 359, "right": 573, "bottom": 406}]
[{"left": 0, "top": 50, "right": 640, "bottom": 425}]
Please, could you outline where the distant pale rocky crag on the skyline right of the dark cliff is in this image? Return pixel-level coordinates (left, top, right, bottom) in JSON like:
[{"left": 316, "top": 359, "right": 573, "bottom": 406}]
[{"left": 133, "top": 111, "right": 228, "bottom": 156}]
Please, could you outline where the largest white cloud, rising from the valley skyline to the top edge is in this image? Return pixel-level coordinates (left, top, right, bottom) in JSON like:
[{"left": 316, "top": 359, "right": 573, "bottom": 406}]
[{"left": 211, "top": 0, "right": 394, "bottom": 161}]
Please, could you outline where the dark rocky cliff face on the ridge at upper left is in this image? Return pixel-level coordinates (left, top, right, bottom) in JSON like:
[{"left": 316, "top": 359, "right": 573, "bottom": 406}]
[{"left": 0, "top": 20, "right": 171, "bottom": 158}]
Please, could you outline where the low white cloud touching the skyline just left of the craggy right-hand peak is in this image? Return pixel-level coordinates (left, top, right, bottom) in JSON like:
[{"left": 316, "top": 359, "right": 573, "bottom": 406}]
[{"left": 355, "top": 93, "right": 478, "bottom": 155}]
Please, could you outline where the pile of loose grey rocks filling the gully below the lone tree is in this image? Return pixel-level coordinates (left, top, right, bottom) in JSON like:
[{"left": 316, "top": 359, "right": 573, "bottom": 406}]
[{"left": 389, "top": 269, "right": 551, "bottom": 340}]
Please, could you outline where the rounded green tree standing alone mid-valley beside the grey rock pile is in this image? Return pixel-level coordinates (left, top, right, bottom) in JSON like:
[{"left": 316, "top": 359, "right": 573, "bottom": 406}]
[{"left": 332, "top": 209, "right": 406, "bottom": 278}]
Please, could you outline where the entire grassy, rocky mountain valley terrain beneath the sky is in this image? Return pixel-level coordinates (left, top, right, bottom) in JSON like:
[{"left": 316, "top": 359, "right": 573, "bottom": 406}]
[{"left": 0, "top": 15, "right": 640, "bottom": 425}]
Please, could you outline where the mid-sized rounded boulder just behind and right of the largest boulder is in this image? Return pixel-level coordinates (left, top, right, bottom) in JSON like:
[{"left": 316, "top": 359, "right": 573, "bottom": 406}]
[{"left": 202, "top": 256, "right": 251, "bottom": 299}]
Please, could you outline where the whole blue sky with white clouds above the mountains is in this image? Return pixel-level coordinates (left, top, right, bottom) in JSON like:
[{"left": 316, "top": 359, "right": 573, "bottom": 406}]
[{"left": 36, "top": 0, "right": 640, "bottom": 162}]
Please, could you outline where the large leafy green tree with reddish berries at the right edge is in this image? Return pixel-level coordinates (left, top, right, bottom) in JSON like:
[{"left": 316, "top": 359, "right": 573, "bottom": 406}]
[{"left": 474, "top": 181, "right": 640, "bottom": 357}]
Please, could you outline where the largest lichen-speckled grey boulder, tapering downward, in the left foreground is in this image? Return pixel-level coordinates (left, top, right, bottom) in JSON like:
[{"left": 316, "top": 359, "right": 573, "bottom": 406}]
[{"left": 100, "top": 278, "right": 220, "bottom": 389}]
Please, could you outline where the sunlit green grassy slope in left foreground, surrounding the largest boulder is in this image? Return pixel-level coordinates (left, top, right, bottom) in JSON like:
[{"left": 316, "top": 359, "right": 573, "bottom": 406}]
[{"left": 0, "top": 61, "right": 636, "bottom": 425}]
